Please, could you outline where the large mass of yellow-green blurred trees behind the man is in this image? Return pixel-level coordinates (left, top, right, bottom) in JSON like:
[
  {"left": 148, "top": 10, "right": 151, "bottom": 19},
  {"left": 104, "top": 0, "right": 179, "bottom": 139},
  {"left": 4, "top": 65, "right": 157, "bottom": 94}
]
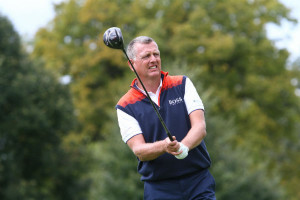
[{"left": 33, "top": 0, "right": 300, "bottom": 199}]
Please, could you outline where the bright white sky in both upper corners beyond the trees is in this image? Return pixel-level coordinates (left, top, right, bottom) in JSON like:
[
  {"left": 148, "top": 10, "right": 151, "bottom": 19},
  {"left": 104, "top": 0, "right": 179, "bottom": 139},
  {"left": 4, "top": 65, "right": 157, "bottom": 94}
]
[{"left": 0, "top": 0, "right": 300, "bottom": 61}]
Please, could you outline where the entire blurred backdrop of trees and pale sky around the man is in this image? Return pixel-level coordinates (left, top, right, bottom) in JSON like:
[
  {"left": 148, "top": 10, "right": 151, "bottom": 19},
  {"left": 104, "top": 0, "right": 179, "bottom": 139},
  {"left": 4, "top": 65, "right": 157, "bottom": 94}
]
[{"left": 0, "top": 0, "right": 300, "bottom": 200}]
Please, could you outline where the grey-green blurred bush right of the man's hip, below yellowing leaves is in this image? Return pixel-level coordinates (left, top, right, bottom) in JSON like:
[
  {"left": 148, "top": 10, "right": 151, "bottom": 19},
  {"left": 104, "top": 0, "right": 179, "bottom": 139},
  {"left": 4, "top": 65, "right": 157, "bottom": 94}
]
[{"left": 203, "top": 98, "right": 284, "bottom": 200}]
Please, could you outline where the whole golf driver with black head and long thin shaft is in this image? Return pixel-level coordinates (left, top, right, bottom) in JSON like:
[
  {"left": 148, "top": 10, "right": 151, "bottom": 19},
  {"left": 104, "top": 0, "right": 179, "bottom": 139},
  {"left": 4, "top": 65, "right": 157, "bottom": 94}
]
[{"left": 103, "top": 27, "right": 174, "bottom": 141}]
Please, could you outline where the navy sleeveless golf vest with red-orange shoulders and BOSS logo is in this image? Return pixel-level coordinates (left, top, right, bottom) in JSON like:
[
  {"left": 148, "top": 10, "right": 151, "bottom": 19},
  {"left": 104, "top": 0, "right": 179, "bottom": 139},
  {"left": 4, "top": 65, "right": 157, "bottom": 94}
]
[{"left": 116, "top": 72, "right": 211, "bottom": 181}]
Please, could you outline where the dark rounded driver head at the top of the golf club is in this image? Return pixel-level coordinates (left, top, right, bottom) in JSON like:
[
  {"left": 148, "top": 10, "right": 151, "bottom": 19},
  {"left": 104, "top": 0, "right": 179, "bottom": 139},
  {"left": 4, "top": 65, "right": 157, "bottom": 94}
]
[{"left": 103, "top": 27, "right": 124, "bottom": 49}]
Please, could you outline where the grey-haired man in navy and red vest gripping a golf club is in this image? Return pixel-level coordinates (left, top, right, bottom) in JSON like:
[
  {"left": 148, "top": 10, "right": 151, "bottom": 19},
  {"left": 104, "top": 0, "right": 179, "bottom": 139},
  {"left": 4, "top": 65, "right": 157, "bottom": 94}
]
[{"left": 116, "top": 36, "right": 215, "bottom": 200}]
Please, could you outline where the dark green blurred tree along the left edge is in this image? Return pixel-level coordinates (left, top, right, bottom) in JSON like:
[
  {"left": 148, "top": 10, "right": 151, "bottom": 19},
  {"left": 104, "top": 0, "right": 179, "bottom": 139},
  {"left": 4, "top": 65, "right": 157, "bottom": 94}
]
[{"left": 0, "top": 15, "right": 88, "bottom": 200}]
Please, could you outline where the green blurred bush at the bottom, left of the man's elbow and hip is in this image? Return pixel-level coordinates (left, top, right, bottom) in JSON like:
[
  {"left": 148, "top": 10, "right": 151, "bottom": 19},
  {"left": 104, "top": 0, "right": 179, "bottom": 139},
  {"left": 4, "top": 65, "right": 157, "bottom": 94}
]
[{"left": 89, "top": 112, "right": 143, "bottom": 200}]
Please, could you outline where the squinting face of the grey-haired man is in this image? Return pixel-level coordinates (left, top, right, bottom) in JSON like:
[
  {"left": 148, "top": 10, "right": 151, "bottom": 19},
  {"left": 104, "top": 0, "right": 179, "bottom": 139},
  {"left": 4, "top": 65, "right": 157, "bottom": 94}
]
[{"left": 132, "top": 42, "right": 161, "bottom": 80}]
